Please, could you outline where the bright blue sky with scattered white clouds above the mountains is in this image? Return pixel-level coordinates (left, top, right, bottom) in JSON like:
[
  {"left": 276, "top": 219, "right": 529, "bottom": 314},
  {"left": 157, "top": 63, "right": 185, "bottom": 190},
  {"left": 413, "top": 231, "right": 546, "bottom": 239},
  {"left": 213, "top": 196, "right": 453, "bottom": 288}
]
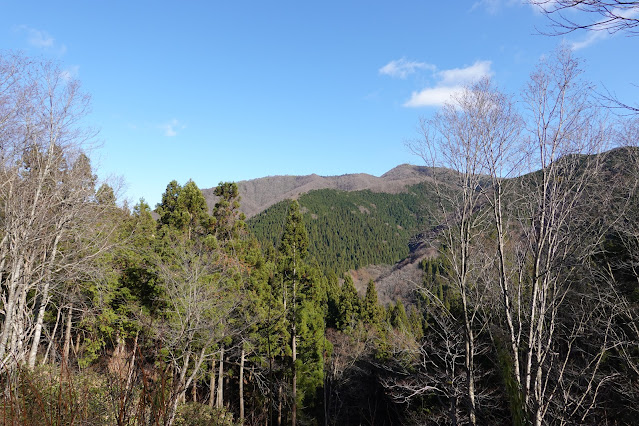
[{"left": 0, "top": 0, "right": 639, "bottom": 206}]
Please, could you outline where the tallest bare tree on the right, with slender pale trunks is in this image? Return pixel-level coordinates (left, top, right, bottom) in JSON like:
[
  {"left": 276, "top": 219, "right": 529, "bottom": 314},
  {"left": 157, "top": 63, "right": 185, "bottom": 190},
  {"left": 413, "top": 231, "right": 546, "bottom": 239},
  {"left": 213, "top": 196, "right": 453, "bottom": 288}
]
[{"left": 517, "top": 48, "right": 610, "bottom": 424}]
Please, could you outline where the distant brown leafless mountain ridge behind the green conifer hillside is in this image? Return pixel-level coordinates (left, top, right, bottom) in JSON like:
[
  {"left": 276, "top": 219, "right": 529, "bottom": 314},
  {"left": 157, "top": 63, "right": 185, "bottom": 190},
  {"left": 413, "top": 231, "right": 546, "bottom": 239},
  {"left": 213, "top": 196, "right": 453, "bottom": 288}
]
[{"left": 202, "top": 164, "right": 432, "bottom": 218}]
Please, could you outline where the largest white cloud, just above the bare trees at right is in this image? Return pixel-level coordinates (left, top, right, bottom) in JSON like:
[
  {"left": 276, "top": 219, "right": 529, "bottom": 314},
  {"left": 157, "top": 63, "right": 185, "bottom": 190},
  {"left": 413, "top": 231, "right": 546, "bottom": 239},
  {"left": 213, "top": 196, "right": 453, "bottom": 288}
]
[{"left": 404, "top": 61, "right": 493, "bottom": 108}]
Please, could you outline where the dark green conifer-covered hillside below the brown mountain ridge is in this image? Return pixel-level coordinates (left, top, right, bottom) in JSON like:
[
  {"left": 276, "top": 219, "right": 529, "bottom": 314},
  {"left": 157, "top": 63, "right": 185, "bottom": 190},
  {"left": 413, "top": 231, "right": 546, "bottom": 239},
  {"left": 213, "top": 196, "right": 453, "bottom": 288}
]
[{"left": 248, "top": 183, "right": 438, "bottom": 275}]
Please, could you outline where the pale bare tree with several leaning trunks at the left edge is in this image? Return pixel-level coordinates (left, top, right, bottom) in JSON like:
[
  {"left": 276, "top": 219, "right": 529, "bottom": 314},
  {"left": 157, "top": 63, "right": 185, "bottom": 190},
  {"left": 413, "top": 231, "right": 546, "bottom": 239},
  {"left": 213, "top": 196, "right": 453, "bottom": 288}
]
[{"left": 0, "top": 52, "right": 113, "bottom": 367}]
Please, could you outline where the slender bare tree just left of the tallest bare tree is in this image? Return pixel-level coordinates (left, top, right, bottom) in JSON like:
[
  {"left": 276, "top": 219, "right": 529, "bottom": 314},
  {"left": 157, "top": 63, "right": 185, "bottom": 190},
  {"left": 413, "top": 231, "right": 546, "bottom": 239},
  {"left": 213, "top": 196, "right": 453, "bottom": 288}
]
[{"left": 410, "top": 79, "right": 516, "bottom": 424}]
